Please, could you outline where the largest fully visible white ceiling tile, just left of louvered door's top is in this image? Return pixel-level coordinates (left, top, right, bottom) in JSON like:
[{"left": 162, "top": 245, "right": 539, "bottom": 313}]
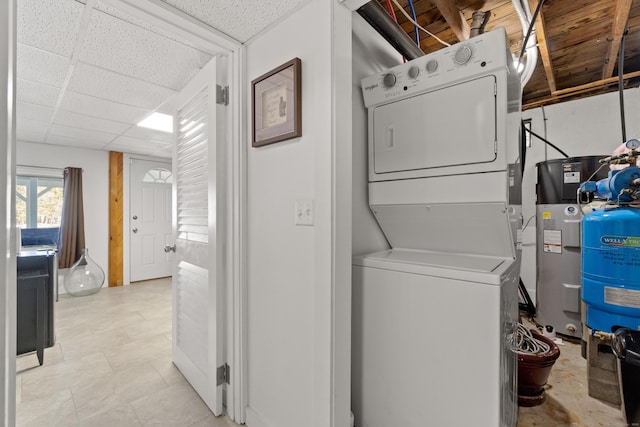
[{"left": 78, "top": 7, "right": 211, "bottom": 90}]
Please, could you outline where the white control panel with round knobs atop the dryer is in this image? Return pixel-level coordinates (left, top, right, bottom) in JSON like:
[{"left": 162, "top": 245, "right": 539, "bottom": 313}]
[{"left": 362, "top": 28, "right": 515, "bottom": 108}]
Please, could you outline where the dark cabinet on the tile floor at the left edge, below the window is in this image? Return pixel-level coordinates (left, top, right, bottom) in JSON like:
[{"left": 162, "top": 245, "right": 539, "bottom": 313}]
[{"left": 16, "top": 251, "right": 58, "bottom": 365}]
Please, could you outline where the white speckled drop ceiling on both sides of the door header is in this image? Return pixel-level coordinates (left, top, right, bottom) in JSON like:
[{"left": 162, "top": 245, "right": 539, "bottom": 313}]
[{"left": 16, "top": 0, "right": 312, "bottom": 157}]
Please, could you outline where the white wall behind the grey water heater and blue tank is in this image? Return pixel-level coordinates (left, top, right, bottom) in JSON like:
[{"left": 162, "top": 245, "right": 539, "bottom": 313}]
[{"left": 521, "top": 88, "right": 640, "bottom": 302}]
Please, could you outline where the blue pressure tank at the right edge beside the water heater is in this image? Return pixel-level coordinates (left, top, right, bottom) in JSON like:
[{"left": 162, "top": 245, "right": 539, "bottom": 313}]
[{"left": 582, "top": 207, "right": 640, "bottom": 332}]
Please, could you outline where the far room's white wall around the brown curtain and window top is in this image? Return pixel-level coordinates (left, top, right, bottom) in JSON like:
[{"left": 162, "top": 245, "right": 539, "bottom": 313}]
[{"left": 16, "top": 141, "right": 109, "bottom": 293}]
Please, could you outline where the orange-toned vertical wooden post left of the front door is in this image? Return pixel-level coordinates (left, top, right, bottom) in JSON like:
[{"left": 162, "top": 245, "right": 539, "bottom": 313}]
[{"left": 109, "top": 151, "right": 124, "bottom": 287}]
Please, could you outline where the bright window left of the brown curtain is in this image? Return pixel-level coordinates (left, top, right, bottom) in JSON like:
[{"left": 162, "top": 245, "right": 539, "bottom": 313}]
[{"left": 16, "top": 175, "right": 64, "bottom": 228}]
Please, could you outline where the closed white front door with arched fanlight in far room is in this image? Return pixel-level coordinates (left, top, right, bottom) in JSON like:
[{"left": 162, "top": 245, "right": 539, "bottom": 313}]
[{"left": 129, "top": 158, "right": 174, "bottom": 282}]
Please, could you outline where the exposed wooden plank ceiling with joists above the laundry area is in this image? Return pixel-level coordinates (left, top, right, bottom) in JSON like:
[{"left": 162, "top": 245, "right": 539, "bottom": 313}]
[{"left": 377, "top": 0, "right": 640, "bottom": 109}]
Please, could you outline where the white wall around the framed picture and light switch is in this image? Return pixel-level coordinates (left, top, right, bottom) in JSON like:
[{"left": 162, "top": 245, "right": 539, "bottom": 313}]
[{"left": 246, "top": 0, "right": 351, "bottom": 427}]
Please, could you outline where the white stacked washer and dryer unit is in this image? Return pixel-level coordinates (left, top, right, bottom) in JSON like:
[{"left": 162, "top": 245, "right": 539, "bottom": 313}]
[{"left": 352, "top": 29, "right": 521, "bottom": 427}]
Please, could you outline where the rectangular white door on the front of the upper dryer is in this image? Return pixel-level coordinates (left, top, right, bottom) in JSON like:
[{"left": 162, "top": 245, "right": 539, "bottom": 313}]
[{"left": 370, "top": 75, "right": 497, "bottom": 179}]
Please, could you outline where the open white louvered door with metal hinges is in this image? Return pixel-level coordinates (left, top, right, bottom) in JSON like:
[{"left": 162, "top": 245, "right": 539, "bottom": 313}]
[{"left": 173, "top": 57, "right": 228, "bottom": 415}]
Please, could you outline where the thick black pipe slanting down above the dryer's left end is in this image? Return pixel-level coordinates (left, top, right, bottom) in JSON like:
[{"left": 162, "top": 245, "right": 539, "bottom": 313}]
[{"left": 357, "top": 0, "right": 424, "bottom": 60}]
